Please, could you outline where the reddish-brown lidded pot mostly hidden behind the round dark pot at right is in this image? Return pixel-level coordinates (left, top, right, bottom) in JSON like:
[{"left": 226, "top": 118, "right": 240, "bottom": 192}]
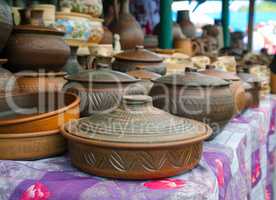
[{"left": 200, "top": 66, "right": 249, "bottom": 113}]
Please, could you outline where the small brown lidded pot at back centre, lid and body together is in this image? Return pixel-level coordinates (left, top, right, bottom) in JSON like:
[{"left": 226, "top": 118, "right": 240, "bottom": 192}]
[{"left": 112, "top": 46, "right": 166, "bottom": 75}]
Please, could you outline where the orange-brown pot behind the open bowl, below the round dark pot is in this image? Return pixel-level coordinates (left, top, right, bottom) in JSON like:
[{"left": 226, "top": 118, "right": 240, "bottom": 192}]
[{"left": 16, "top": 72, "right": 67, "bottom": 92}]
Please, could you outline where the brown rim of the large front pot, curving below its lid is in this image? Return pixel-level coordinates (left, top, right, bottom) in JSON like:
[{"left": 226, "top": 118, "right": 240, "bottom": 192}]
[{"left": 60, "top": 124, "right": 213, "bottom": 149}]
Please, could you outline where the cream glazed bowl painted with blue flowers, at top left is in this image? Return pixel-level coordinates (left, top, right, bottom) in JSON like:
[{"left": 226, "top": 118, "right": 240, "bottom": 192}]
[{"left": 55, "top": 12, "right": 104, "bottom": 43}]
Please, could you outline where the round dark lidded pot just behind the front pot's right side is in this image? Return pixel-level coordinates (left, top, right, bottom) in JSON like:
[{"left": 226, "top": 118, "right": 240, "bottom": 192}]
[{"left": 150, "top": 68, "right": 234, "bottom": 139}]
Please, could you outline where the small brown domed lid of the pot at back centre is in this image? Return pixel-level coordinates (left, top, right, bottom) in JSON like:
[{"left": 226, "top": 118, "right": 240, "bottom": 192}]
[{"left": 114, "top": 46, "right": 163, "bottom": 62}]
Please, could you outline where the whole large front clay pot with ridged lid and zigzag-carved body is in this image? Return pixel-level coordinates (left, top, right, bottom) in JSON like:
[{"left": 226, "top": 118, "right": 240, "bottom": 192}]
[{"left": 62, "top": 95, "right": 212, "bottom": 179}]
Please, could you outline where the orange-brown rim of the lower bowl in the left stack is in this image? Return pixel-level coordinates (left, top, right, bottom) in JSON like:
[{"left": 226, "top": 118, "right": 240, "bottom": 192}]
[{"left": 0, "top": 129, "right": 61, "bottom": 140}]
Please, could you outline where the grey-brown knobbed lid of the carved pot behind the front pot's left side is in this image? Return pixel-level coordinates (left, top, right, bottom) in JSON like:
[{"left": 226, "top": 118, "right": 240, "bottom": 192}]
[{"left": 65, "top": 64, "right": 139, "bottom": 83}]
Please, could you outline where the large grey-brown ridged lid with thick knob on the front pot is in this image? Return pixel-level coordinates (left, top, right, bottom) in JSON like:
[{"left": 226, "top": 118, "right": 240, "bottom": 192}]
[{"left": 64, "top": 95, "right": 212, "bottom": 144}]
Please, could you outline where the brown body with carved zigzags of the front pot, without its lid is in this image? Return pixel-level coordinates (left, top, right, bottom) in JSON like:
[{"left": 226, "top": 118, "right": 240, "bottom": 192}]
[{"left": 69, "top": 139, "right": 202, "bottom": 179}]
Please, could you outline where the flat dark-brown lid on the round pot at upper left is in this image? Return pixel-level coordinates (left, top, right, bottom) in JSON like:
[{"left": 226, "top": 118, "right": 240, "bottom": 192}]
[{"left": 13, "top": 25, "right": 65, "bottom": 36}]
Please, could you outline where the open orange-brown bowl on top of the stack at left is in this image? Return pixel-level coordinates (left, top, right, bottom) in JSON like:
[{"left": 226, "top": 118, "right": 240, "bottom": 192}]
[{"left": 0, "top": 93, "right": 80, "bottom": 134}]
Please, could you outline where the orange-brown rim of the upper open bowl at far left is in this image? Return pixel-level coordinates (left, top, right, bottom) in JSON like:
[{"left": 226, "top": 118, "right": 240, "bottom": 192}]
[{"left": 0, "top": 92, "right": 80, "bottom": 126}]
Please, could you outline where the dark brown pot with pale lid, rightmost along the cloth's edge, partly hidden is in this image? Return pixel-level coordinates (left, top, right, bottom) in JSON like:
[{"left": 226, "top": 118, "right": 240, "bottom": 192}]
[{"left": 238, "top": 73, "right": 261, "bottom": 107}]
